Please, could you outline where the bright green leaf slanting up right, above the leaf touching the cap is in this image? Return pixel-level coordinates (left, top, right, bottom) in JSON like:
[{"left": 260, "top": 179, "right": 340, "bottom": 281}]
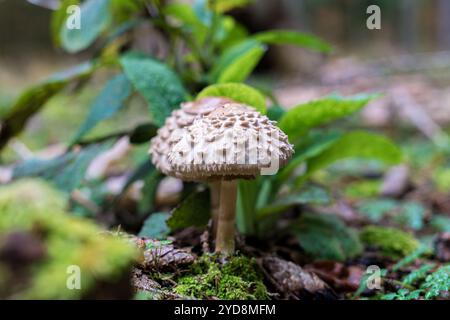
[{"left": 217, "top": 46, "right": 266, "bottom": 83}]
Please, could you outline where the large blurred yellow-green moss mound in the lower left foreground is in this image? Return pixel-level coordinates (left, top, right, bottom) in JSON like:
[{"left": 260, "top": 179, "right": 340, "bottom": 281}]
[{"left": 0, "top": 179, "right": 138, "bottom": 299}]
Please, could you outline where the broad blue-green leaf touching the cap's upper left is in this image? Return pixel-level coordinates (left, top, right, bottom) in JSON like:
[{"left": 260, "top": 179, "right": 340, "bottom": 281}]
[{"left": 120, "top": 52, "right": 187, "bottom": 126}]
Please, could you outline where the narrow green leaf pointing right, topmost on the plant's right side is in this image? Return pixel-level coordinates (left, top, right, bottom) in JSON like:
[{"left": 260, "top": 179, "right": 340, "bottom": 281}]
[{"left": 253, "top": 30, "right": 331, "bottom": 53}]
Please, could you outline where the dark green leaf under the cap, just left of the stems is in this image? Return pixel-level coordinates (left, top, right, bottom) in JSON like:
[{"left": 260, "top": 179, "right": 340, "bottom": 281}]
[{"left": 167, "top": 190, "right": 211, "bottom": 231}]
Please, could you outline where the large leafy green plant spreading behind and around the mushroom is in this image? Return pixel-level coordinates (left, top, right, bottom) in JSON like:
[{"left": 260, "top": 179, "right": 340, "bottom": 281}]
[{"left": 0, "top": 0, "right": 401, "bottom": 259}]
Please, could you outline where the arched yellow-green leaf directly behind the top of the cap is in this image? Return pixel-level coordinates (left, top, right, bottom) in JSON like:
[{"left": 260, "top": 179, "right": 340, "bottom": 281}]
[{"left": 197, "top": 83, "right": 266, "bottom": 114}]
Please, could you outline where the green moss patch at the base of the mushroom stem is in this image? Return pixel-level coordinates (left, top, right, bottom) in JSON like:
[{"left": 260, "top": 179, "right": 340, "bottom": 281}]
[{"left": 174, "top": 255, "right": 268, "bottom": 300}]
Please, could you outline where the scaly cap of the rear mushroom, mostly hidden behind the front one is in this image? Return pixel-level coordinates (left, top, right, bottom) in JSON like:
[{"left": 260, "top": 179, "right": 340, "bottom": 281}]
[{"left": 149, "top": 97, "right": 232, "bottom": 177}]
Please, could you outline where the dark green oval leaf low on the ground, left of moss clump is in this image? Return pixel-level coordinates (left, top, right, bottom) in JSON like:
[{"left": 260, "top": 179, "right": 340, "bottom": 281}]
[{"left": 292, "top": 213, "right": 362, "bottom": 261}]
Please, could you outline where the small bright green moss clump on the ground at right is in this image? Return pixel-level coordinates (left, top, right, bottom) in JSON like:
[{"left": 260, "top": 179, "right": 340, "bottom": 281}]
[{"left": 360, "top": 226, "right": 419, "bottom": 258}]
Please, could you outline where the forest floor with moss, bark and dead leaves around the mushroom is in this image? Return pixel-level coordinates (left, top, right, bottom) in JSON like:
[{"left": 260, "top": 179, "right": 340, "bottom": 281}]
[{"left": 0, "top": 55, "right": 450, "bottom": 299}]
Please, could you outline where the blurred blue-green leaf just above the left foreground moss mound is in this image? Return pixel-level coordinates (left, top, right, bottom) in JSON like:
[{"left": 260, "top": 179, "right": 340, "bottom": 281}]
[{"left": 13, "top": 143, "right": 110, "bottom": 192}]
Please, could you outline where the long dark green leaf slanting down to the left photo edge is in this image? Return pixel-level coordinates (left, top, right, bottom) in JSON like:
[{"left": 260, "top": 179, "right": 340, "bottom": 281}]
[{"left": 0, "top": 63, "right": 95, "bottom": 150}]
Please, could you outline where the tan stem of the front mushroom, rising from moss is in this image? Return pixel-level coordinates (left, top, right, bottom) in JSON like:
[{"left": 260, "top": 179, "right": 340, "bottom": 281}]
[{"left": 216, "top": 180, "right": 237, "bottom": 255}]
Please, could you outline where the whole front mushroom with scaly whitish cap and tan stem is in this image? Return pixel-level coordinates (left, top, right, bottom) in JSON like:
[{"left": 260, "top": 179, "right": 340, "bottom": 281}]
[{"left": 168, "top": 103, "right": 293, "bottom": 255}]
